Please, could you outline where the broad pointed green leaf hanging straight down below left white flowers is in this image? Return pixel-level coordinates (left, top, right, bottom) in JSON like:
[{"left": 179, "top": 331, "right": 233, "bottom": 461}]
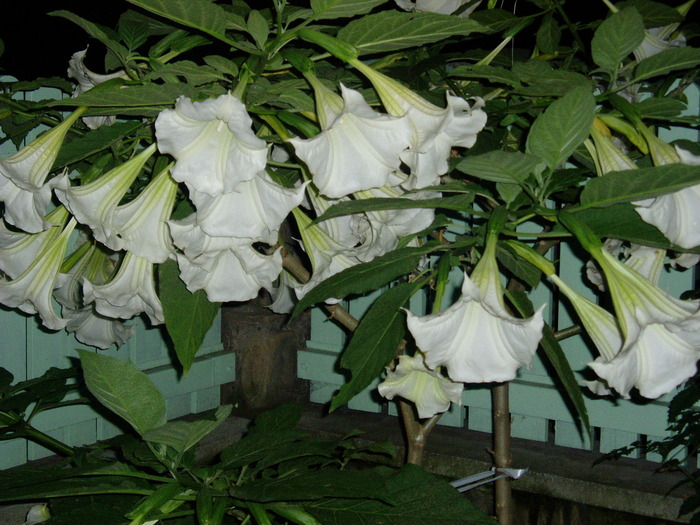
[{"left": 158, "top": 260, "right": 221, "bottom": 374}]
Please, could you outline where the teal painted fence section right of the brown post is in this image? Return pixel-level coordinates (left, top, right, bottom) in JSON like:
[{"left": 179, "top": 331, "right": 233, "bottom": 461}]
[{"left": 298, "top": 86, "right": 700, "bottom": 466}]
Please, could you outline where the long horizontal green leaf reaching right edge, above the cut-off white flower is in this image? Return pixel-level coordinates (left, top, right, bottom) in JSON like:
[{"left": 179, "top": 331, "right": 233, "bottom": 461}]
[{"left": 579, "top": 164, "right": 700, "bottom": 209}]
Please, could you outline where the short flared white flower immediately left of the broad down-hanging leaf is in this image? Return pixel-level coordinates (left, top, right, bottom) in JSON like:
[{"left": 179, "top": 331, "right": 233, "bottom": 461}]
[{"left": 83, "top": 252, "right": 163, "bottom": 325}]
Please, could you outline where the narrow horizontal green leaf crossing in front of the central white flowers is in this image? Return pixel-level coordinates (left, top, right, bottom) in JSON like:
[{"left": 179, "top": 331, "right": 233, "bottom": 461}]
[{"left": 314, "top": 193, "right": 474, "bottom": 222}]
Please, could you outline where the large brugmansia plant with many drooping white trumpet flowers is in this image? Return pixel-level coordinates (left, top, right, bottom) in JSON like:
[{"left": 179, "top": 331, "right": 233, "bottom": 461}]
[{"left": 0, "top": 0, "right": 700, "bottom": 523}]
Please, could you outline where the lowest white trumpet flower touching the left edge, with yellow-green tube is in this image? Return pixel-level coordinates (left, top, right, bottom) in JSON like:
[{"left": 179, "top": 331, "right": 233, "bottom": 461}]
[{"left": 0, "top": 219, "right": 76, "bottom": 330}]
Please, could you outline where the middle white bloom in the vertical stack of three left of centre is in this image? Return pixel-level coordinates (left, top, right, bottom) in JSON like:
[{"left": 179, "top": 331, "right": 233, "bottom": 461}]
[{"left": 190, "top": 171, "right": 306, "bottom": 244}]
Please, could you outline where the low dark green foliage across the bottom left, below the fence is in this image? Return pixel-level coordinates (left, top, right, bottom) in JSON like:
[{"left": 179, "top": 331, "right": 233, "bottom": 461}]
[{"left": 0, "top": 358, "right": 495, "bottom": 525}]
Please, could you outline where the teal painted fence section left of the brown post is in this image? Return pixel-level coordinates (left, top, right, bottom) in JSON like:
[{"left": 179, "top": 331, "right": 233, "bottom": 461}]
[{"left": 0, "top": 77, "right": 235, "bottom": 469}]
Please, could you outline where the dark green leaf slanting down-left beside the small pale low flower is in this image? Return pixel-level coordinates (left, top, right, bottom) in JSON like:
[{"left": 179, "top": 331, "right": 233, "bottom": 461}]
[{"left": 330, "top": 281, "right": 423, "bottom": 412}]
